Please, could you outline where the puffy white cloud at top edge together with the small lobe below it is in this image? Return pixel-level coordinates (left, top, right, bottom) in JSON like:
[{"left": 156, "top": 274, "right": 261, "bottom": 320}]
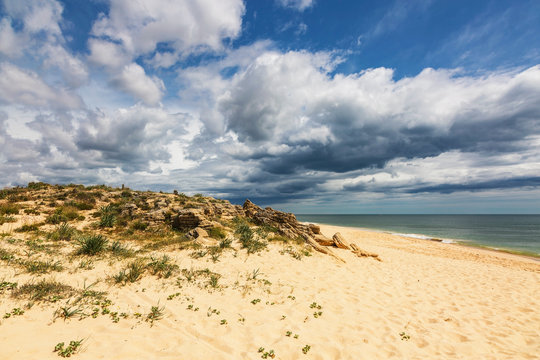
[{"left": 88, "top": 0, "right": 245, "bottom": 104}]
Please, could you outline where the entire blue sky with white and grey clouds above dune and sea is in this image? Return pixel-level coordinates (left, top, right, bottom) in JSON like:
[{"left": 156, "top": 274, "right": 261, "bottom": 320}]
[{"left": 0, "top": 0, "right": 540, "bottom": 214}]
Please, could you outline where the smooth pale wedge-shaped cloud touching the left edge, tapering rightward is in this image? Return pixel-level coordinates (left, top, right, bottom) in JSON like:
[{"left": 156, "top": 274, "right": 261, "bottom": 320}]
[{"left": 0, "top": 62, "right": 83, "bottom": 109}]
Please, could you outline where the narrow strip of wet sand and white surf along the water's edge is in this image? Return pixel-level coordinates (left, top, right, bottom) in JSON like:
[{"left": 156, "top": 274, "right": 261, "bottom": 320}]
[{"left": 301, "top": 221, "right": 540, "bottom": 262}]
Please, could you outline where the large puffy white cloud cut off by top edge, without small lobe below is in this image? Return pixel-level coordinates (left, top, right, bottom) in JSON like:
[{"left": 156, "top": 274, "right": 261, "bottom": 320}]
[{"left": 92, "top": 0, "right": 244, "bottom": 60}]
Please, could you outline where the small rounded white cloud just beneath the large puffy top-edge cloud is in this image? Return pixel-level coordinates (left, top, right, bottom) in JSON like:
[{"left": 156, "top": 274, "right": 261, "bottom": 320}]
[{"left": 113, "top": 63, "right": 165, "bottom": 105}]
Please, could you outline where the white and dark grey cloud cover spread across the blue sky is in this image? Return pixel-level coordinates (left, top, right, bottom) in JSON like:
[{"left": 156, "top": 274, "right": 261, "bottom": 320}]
[{"left": 0, "top": 0, "right": 540, "bottom": 212}]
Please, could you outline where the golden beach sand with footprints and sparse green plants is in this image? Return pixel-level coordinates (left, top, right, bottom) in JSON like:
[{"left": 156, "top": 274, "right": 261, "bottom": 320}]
[{"left": 0, "top": 219, "right": 540, "bottom": 359}]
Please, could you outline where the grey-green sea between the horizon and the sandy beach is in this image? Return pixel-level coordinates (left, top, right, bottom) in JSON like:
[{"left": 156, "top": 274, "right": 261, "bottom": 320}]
[{"left": 296, "top": 214, "right": 540, "bottom": 256}]
